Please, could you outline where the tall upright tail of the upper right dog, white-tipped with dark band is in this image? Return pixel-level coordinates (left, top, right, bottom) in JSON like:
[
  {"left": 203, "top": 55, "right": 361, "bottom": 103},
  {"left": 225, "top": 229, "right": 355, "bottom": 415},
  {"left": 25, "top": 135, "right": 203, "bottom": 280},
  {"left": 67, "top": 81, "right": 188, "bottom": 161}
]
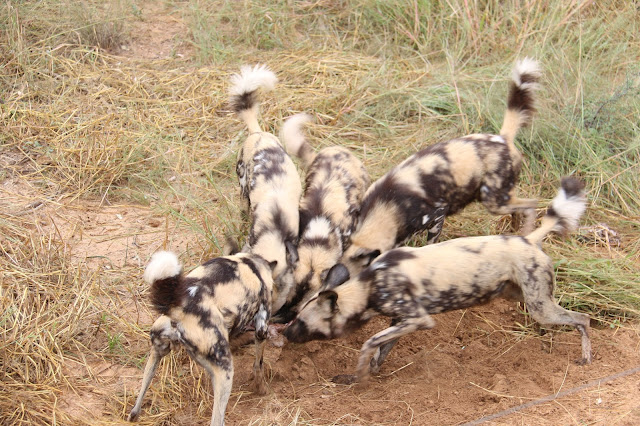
[{"left": 500, "top": 58, "right": 540, "bottom": 159}]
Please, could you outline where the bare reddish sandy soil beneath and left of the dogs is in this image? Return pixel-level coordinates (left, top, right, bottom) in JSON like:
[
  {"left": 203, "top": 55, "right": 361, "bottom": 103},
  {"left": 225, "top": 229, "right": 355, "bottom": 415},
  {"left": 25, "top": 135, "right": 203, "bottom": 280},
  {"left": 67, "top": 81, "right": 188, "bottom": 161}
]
[{"left": 10, "top": 181, "right": 640, "bottom": 425}]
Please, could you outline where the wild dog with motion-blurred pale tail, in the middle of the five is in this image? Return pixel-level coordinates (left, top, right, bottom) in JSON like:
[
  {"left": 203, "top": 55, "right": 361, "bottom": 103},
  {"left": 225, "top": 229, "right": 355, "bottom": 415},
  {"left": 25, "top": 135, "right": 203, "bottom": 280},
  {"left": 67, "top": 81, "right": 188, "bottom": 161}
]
[{"left": 275, "top": 114, "right": 369, "bottom": 322}]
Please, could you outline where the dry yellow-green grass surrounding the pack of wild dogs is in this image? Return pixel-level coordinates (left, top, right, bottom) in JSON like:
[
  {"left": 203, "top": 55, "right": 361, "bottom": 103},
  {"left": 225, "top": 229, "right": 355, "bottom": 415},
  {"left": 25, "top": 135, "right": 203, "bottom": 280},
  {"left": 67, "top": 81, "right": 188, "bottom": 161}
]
[{"left": 0, "top": 0, "right": 640, "bottom": 424}]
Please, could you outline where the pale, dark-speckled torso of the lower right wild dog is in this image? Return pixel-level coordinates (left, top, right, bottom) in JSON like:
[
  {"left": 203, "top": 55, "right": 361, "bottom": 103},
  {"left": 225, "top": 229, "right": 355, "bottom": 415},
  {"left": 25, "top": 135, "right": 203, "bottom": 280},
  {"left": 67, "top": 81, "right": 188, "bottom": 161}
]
[{"left": 362, "top": 236, "right": 553, "bottom": 316}]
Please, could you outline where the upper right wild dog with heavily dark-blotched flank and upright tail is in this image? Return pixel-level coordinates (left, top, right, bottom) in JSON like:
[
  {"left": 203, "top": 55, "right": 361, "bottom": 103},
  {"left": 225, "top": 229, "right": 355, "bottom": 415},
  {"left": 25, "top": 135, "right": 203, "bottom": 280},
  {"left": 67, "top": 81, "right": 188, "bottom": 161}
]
[{"left": 342, "top": 58, "right": 540, "bottom": 275}]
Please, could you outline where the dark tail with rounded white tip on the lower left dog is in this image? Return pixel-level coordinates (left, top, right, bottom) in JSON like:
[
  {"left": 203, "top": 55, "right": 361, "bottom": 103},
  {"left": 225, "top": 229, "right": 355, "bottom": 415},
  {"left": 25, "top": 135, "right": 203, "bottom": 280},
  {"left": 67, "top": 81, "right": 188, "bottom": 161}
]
[{"left": 144, "top": 251, "right": 184, "bottom": 315}]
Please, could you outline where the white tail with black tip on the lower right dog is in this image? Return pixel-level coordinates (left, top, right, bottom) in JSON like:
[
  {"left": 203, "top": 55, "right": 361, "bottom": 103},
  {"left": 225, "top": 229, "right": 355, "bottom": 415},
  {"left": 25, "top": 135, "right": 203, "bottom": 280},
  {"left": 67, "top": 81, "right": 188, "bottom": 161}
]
[{"left": 525, "top": 177, "right": 586, "bottom": 245}]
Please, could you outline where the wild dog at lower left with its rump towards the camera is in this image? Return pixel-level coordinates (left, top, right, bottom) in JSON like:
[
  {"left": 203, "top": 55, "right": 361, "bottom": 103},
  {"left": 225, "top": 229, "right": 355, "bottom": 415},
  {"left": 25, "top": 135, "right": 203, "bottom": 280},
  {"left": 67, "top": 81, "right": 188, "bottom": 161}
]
[{"left": 129, "top": 251, "right": 273, "bottom": 425}]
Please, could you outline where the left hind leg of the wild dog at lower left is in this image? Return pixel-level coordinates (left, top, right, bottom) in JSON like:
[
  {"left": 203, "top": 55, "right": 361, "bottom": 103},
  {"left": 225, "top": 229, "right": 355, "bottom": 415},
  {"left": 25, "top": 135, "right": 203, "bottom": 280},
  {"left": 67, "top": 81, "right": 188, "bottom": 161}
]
[{"left": 128, "top": 315, "right": 179, "bottom": 422}]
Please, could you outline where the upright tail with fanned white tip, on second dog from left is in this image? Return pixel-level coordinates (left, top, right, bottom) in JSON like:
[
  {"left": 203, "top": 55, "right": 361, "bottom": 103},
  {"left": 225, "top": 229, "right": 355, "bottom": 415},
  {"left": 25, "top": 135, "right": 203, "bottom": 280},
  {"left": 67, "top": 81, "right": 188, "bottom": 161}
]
[{"left": 229, "top": 65, "right": 278, "bottom": 133}]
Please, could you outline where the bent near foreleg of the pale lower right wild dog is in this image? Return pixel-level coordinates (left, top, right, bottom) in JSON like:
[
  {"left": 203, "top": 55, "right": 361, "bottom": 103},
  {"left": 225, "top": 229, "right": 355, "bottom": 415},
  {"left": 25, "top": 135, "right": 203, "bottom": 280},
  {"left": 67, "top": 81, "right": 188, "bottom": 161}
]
[{"left": 356, "top": 313, "right": 436, "bottom": 382}]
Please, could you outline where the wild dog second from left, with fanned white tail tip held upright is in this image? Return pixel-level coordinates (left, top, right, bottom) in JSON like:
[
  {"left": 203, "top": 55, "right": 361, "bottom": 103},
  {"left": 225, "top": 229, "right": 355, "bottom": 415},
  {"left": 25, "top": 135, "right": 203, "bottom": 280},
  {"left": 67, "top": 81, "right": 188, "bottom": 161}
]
[{"left": 230, "top": 65, "right": 302, "bottom": 312}]
